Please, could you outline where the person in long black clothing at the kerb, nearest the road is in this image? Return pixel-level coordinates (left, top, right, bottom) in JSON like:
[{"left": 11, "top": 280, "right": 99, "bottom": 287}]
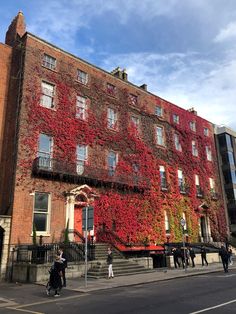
[{"left": 46, "top": 254, "right": 63, "bottom": 297}]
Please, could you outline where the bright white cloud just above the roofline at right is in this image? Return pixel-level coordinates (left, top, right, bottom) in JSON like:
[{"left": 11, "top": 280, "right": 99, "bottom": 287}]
[{"left": 99, "top": 53, "right": 236, "bottom": 130}]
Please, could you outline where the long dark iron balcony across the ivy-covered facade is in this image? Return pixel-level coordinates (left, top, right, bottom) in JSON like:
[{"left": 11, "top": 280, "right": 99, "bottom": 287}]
[{"left": 33, "top": 157, "right": 150, "bottom": 192}]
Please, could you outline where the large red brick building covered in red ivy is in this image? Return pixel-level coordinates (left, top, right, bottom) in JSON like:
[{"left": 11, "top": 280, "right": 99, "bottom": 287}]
[{"left": 0, "top": 12, "right": 227, "bottom": 260}]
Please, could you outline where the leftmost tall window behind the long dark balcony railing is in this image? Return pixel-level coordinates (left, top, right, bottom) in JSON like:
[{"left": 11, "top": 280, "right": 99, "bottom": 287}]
[{"left": 37, "top": 134, "right": 53, "bottom": 169}]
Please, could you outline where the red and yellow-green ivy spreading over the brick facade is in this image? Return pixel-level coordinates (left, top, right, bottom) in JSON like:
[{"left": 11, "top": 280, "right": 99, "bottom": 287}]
[{"left": 18, "top": 68, "right": 226, "bottom": 243}]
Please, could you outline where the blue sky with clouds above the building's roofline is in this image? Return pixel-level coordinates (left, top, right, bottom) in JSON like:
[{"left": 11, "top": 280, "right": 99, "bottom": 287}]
[{"left": 0, "top": 0, "right": 236, "bottom": 131}]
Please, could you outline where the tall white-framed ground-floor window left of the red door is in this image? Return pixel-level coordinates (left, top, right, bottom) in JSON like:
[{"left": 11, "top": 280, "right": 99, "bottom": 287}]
[{"left": 33, "top": 192, "right": 50, "bottom": 232}]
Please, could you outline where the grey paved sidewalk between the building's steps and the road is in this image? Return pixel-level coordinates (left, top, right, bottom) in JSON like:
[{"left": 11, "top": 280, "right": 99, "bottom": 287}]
[{"left": 63, "top": 263, "right": 236, "bottom": 292}]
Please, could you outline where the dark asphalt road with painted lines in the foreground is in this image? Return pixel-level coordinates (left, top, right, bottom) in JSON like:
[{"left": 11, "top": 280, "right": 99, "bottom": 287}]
[{"left": 0, "top": 271, "right": 236, "bottom": 314}]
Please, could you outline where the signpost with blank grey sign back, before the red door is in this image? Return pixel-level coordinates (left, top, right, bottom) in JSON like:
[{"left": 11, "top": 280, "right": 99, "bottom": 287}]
[{"left": 82, "top": 205, "right": 94, "bottom": 288}]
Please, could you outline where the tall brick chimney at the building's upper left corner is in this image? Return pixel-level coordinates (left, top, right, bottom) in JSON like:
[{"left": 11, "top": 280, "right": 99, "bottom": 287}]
[{"left": 5, "top": 11, "right": 26, "bottom": 46}]
